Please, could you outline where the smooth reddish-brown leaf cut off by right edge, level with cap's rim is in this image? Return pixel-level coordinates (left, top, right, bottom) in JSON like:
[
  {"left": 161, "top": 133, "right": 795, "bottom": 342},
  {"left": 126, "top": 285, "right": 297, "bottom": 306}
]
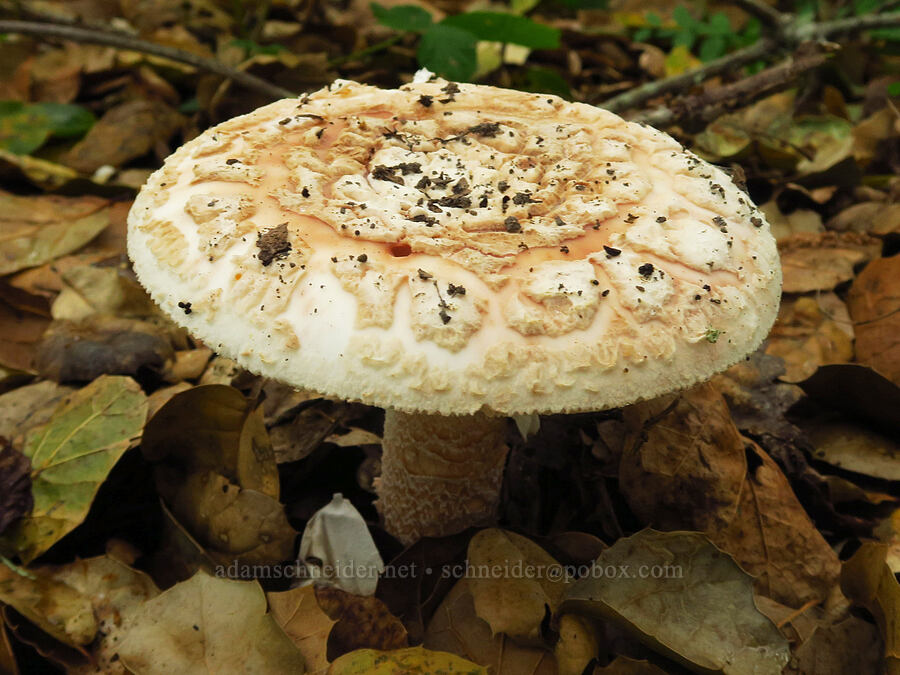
[{"left": 847, "top": 256, "right": 900, "bottom": 384}]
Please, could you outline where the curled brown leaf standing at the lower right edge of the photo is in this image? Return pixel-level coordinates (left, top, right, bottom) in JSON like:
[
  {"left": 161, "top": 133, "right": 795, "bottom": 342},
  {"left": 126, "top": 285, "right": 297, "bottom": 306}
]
[{"left": 841, "top": 542, "right": 900, "bottom": 675}]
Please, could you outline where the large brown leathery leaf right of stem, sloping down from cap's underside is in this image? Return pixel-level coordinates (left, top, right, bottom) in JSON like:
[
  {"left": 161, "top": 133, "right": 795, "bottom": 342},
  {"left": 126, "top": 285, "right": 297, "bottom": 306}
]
[{"left": 620, "top": 383, "right": 840, "bottom": 607}]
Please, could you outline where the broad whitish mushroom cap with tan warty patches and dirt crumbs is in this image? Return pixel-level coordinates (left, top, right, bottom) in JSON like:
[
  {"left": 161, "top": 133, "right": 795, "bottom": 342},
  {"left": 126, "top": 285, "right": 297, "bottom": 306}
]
[{"left": 128, "top": 80, "right": 781, "bottom": 414}]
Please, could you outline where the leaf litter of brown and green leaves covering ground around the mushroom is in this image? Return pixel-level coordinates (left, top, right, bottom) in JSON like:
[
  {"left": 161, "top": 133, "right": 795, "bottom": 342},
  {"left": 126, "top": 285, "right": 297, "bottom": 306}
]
[{"left": 0, "top": 0, "right": 900, "bottom": 675}]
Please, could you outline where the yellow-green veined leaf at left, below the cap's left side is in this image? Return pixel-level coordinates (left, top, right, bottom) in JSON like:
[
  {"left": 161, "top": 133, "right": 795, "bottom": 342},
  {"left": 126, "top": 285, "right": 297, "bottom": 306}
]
[{"left": 0, "top": 375, "right": 147, "bottom": 563}]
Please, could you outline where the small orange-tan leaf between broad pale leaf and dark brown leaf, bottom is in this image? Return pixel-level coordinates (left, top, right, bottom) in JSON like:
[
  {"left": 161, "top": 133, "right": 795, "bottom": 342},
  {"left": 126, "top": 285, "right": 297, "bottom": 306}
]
[{"left": 266, "top": 586, "right": 337, "bottom": 674}]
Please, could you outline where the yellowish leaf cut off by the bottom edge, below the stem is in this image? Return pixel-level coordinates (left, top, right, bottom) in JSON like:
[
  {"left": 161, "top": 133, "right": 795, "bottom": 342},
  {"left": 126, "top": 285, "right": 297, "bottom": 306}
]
[{"left": 328, "top": 647, "right": 488, "bottom": 675}]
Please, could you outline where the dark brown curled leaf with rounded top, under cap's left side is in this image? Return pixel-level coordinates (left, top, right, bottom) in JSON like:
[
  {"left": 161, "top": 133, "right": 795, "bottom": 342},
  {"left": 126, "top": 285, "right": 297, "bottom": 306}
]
[{"left": 141, "top": 384, "right": 279, "bottom": 500}]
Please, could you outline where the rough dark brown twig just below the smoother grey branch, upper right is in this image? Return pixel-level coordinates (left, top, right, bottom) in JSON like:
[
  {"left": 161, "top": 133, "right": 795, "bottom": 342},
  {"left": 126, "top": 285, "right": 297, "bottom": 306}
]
[{"left": 632, "top": 46, "right": 828, "bottom": 127}]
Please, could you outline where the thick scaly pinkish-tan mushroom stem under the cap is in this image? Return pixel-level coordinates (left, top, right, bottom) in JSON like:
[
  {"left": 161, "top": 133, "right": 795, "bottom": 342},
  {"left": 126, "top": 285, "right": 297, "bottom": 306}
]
[{"left": 376, "top": 410, "right": 509, "bottom": 544}]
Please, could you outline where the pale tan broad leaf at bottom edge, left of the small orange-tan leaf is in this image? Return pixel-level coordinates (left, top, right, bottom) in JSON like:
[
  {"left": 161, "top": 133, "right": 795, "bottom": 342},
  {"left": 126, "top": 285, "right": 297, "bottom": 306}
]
[{"left": 119, "top": 572, "right": 305, "bottom": 675}]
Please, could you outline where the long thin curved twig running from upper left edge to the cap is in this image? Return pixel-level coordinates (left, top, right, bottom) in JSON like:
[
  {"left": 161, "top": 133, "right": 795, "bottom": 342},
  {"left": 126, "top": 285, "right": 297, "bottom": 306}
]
[{"left": 0, "top": 20, "right": 297, "bottom": 99}]
